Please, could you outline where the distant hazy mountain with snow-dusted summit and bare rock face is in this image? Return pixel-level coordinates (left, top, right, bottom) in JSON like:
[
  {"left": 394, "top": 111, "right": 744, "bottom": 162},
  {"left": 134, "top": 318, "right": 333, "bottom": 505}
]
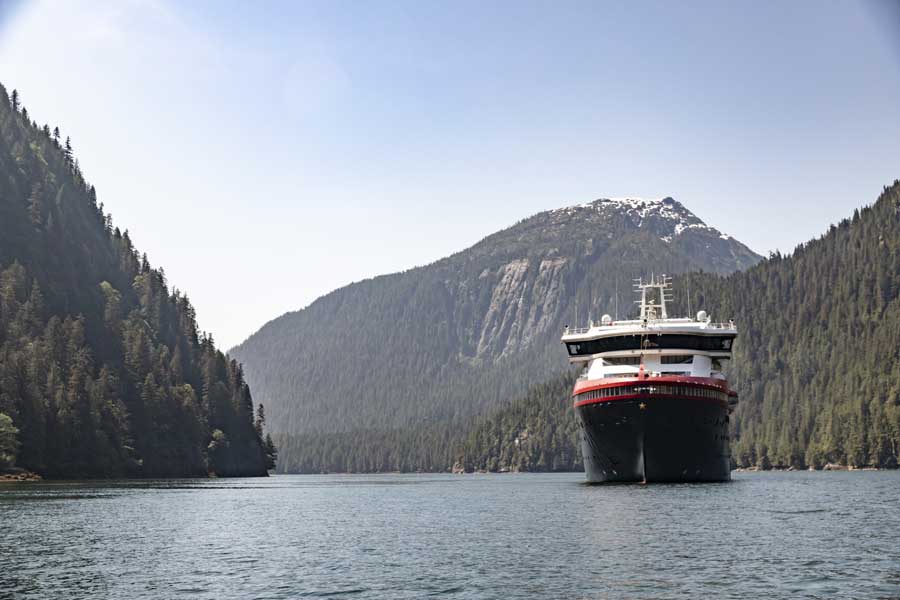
[{"left": 231, "top": 192, "right": 760, "bottom": 464}]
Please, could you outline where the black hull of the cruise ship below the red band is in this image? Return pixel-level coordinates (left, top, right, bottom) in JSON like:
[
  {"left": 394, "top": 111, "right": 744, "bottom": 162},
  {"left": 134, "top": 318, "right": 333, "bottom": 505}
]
[{"left": 575, "top": 394, "right": 731, "bottom": 483}]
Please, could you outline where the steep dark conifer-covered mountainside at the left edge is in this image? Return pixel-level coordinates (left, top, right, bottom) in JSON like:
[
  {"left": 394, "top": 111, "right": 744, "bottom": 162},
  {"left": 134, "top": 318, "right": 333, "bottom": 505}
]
[{"left": 0, "top": 86, "right": 273, "bottom": 478}]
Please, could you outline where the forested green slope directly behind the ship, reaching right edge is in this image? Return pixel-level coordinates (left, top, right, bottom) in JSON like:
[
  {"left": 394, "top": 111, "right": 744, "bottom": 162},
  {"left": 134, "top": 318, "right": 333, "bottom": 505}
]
[{"left": 458, "top": 181, "right": 900, "bottom": 470}]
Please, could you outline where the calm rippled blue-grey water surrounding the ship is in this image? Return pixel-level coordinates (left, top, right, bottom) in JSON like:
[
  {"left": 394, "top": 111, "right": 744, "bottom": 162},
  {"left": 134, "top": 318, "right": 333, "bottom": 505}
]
[{"left": 0, "top": 472, "right": 900, "bottom": 599}]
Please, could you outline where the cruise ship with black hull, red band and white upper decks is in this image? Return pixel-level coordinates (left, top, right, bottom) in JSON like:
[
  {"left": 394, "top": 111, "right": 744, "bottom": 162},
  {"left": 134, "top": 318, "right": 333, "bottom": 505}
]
[{"left": 562, "top": 275, "right": 737, "bottom": 483}]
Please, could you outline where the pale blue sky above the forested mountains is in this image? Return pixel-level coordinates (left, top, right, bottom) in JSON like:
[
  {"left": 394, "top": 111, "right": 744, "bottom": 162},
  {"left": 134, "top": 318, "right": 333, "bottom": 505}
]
[{"left": 0, "top": 0, "right": 900, "bottom": 347}]
